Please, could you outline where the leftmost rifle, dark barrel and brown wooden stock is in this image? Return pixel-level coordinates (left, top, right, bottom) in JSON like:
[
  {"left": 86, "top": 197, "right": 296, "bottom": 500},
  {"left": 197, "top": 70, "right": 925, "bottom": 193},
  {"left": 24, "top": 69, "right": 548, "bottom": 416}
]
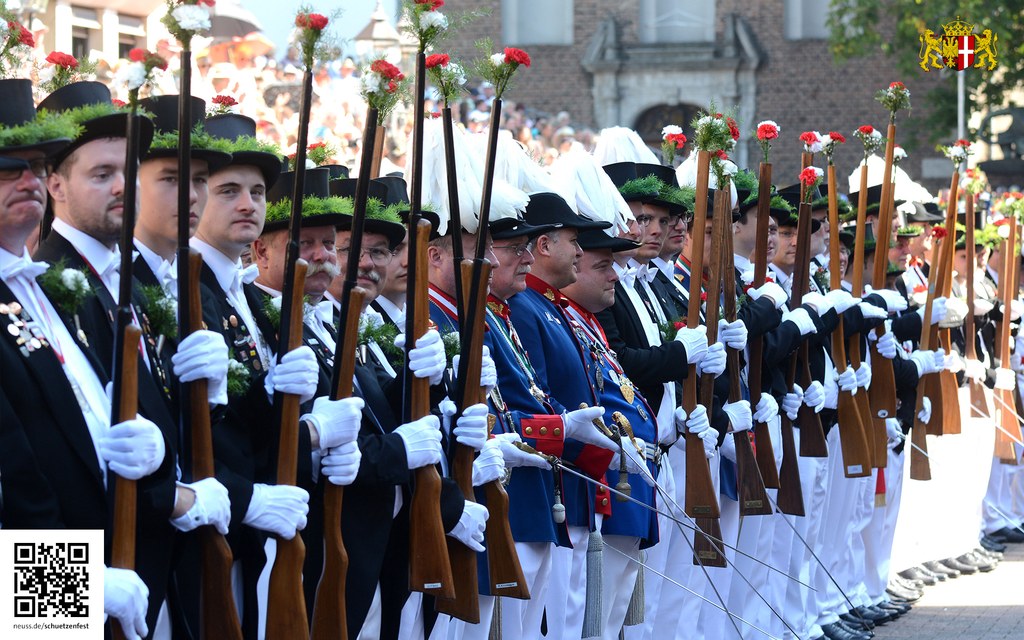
[{"left": 111, "top": 84, "right": 144, "bottom": 640}]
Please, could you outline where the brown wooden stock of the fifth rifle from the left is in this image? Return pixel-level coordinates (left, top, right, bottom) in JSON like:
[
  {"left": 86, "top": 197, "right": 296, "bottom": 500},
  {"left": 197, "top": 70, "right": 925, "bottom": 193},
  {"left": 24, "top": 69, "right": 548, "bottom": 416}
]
[{"left": 406, "top": 219, "right": 455, "bottom": 599}]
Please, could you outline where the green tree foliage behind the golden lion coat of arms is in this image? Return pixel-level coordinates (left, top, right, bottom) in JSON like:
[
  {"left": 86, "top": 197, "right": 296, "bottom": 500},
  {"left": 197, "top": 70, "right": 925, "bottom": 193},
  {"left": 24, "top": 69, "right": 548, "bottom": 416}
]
[{"left": 828, "top": 0, "right": 1024, "bottom": 141}]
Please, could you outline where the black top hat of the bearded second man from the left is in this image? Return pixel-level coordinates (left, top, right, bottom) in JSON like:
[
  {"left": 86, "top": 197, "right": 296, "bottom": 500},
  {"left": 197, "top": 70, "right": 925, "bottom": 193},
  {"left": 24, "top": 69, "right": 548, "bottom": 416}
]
[{"left": 39, "top": 81, "right": 153, "bottom": 168}]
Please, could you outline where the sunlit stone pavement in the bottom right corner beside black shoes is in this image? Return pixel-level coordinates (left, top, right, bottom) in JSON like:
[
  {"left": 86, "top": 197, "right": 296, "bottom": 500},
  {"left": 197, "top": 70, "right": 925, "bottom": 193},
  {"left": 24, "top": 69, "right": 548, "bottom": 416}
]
[{"left": 874, "top": 545, "right": 1024, "bottom": 640}]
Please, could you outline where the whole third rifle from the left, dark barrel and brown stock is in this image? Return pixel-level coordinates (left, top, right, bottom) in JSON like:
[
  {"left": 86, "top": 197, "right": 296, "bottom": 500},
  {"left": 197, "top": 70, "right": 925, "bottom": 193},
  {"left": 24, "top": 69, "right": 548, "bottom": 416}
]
[{"left": 266, "top": 59, "right": 311, "bottom": 638}]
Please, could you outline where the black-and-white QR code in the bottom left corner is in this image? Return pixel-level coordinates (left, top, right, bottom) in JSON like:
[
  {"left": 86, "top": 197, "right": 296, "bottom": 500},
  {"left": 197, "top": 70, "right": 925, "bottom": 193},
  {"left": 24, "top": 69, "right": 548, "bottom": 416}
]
[{"left": 14, "top": 543, "right": 89, "bottom": 617}]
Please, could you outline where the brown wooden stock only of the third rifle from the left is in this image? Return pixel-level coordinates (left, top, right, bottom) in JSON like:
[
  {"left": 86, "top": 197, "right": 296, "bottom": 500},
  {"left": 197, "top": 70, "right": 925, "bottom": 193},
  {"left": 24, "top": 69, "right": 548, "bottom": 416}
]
[{"left": 266, "top": 259, "right": 309, "bottom": 638}]
